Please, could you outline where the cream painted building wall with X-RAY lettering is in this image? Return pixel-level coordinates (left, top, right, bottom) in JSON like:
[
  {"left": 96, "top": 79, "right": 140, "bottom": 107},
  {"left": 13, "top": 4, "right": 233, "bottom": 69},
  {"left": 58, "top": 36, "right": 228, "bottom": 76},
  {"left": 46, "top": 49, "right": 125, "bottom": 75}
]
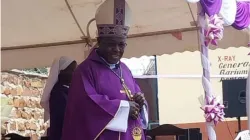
[{"left": 157, "top": 47, "right": 250, "bottom": 124}]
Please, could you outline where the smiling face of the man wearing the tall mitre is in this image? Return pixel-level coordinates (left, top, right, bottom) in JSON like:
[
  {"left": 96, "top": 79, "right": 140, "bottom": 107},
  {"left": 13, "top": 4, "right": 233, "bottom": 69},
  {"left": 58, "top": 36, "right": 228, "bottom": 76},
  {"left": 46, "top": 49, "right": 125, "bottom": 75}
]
[{"left": 99, "top": 37, "right": 127, "bottom": 64}]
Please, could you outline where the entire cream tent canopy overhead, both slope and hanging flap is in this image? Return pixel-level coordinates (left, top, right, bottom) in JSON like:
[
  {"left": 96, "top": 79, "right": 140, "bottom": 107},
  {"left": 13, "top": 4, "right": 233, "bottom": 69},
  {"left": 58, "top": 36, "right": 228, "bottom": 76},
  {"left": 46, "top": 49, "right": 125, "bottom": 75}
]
[{"left": 2, "top": 0, "right": 249, "bottom": 70}]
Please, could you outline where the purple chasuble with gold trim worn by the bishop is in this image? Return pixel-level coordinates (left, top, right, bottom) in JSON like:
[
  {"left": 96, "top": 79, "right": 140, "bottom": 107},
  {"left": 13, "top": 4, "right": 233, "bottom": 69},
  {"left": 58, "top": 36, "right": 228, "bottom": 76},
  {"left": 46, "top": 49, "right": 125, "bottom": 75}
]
[{"left": 62, "top": 49, "right": 145, "bottom": 140}]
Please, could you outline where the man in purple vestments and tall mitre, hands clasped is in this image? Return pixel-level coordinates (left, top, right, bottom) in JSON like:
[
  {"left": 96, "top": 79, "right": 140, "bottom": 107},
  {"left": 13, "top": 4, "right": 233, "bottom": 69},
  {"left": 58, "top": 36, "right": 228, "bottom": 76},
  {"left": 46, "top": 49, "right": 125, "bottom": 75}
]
[{"left": 62, "top": 0, "right": 148, "bottom": 140}]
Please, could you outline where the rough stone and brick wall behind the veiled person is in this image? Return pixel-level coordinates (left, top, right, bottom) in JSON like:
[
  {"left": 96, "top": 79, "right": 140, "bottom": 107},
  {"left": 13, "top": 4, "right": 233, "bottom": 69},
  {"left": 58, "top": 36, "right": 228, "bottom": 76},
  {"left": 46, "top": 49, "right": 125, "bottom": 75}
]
[{"left": 1, "top": 72, "right": 48, "bottom": 137}]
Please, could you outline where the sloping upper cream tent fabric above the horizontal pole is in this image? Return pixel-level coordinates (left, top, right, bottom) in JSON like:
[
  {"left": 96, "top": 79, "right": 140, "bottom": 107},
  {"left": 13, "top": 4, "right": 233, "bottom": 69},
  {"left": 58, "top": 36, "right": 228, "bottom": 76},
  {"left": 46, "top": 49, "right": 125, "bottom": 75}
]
[{"left": 2, "top": 0, "right": 196, "bottom": 47}]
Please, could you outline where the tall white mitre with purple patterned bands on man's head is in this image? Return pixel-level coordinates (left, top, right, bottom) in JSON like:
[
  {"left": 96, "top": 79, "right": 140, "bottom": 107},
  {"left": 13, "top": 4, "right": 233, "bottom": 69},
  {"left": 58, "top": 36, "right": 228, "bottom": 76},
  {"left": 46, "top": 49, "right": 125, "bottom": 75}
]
[{"left": 95, "top": 0, "right": 132, "bottom": 37}]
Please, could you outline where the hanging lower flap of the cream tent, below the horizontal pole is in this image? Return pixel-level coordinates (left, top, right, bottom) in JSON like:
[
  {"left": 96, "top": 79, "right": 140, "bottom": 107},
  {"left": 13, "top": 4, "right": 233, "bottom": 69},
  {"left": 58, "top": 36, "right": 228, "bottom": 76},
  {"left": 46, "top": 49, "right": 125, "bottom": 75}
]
[{"left": 2, "top": 27, "right": 249, "bottom": 70}]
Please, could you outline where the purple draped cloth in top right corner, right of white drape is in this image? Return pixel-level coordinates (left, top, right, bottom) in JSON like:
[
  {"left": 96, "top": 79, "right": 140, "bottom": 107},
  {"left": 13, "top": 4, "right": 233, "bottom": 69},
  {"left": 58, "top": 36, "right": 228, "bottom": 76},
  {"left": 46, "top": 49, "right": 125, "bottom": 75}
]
[{"left": 232, "top": 1, "right": 250, "bottom": 30}]
